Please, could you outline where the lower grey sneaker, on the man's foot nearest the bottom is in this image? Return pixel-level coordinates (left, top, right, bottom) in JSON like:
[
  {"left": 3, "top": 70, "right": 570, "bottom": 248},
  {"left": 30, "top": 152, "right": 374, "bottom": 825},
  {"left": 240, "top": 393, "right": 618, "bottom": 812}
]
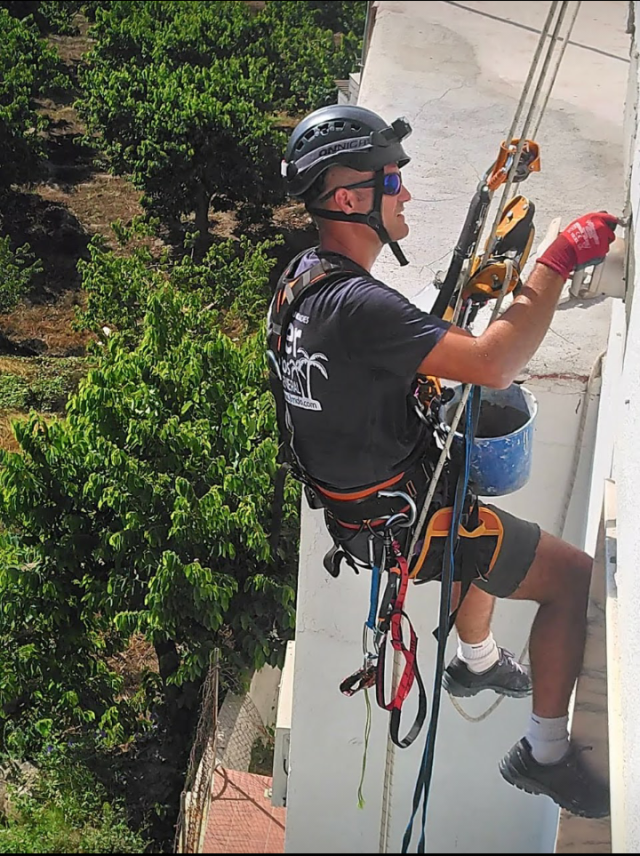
[{"left": 500, "top": 737, "right": 609, "bottom": 817}]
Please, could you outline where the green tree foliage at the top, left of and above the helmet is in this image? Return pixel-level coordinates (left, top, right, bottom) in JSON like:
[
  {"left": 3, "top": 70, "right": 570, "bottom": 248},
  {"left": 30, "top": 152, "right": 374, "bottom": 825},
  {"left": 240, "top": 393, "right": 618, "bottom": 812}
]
[{"left": 74, "top": 0, "right": 365, "bottom": 251}]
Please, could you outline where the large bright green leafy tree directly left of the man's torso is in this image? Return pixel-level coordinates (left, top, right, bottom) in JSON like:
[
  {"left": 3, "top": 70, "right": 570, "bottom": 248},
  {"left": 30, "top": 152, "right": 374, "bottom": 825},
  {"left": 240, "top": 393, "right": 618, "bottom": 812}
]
[{"left": 0, "top": 268, "right": 298, "bottom": 741}]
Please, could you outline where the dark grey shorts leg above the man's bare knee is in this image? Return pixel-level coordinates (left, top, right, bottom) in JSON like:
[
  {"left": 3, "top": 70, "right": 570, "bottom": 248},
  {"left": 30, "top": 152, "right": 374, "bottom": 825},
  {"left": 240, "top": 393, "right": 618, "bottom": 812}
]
[{"left": 474, "top": 503, "right": 540, "bottom": 597}]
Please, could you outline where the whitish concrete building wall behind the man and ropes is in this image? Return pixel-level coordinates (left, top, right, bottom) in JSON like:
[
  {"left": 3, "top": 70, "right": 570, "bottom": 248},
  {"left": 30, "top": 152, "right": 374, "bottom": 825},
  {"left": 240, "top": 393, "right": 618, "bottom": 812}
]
[{"left": 287, "top": 0, "right": 628, "bottom": 853}]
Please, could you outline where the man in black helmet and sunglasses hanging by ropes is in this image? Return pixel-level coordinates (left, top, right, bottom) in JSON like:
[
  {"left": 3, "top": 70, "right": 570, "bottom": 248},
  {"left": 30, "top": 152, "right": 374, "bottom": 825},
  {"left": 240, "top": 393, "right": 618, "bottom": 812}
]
[{"left": 271, "top": 105, "right": 617, "bottom": 817}]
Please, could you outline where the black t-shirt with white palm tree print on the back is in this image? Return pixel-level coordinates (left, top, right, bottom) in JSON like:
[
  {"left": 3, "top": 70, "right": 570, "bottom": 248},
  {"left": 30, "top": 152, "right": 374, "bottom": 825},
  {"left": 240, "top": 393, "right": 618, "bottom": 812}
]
[{"left": 281, "top": 250, "right": 450, "bottom": 490}]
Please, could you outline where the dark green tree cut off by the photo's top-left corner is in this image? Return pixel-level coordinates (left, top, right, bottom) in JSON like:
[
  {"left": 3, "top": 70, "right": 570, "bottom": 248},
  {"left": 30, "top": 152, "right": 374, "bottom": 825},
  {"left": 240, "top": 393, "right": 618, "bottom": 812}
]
[{"left": 0, "top": 9, "right": 64, "bottom": 195}]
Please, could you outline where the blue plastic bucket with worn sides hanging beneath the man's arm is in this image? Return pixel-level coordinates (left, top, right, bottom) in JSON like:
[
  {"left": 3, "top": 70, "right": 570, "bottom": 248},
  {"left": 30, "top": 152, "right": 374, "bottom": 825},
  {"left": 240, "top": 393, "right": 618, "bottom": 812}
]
[{"left": 444, "top": 383, "right": 538, "bottom": 496}]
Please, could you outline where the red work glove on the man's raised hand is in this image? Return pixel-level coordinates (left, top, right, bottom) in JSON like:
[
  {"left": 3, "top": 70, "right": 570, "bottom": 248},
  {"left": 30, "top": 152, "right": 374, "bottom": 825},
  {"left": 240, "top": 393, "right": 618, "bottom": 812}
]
[{"left": 538, "top": 211, "right": 618, "bottom": 279}]
